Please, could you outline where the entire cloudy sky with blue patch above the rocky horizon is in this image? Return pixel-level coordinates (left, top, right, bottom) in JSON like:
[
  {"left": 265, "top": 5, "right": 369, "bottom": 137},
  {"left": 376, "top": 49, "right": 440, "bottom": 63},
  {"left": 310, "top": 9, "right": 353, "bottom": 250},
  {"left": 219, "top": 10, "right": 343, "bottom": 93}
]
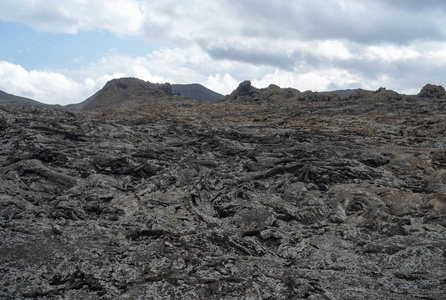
[{"left": 0, "top": 0, "right": 446, "bottom": 104}]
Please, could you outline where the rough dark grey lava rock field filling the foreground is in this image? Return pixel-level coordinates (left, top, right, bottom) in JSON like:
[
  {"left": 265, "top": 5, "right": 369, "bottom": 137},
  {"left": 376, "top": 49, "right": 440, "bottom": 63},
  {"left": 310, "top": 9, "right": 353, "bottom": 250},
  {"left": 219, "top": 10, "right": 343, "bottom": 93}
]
[{"left": 0, "top": 82, "right": 446, "bottom": 299}]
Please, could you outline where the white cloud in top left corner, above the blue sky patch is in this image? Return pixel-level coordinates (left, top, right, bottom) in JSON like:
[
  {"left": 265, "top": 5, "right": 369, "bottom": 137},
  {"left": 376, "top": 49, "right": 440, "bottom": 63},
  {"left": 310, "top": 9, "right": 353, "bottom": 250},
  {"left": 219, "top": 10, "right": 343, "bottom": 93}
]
[{"left": 0, "top": 0, "right": 143, "bottom": 35}]
